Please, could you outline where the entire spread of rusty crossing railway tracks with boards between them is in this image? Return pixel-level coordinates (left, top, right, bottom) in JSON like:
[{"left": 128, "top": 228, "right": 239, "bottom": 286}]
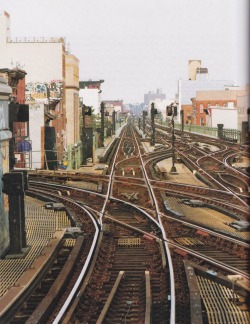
[{"left": 2, "top": 122, "right": 250, "bottom": 323}]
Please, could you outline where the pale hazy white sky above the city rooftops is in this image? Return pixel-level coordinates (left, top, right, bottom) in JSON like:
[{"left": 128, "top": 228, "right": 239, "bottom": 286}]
[{"left": 0, "top": 0, "right": 249, "bottom": 103}]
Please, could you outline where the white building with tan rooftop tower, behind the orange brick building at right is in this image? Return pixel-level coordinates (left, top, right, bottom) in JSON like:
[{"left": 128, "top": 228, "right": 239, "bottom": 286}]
[{"left": 177, "top": 60, "right": 234, "bottom": 123}]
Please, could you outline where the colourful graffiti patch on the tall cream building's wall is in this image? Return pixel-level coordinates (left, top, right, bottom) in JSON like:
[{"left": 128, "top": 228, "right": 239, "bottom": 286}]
[{"left": 25, "top": 80, "right": 63, "bottom": 102}]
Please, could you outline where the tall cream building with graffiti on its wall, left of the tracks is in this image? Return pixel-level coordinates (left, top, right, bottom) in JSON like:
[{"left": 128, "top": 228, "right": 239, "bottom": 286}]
[{"left": 0, "top": 12, "right": 79, "bottom": 169}]
